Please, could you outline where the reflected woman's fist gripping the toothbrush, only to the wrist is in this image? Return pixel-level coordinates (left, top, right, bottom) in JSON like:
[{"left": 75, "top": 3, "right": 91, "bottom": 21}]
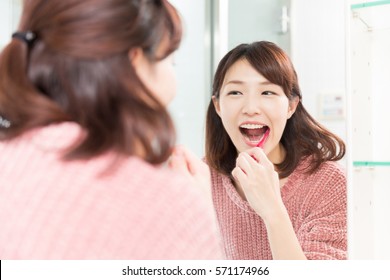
[{"left": 232, "top": 147, "right": 284, "bottom": 222}]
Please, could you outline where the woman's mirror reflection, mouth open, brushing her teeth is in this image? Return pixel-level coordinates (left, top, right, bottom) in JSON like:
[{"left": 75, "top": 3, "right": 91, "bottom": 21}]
[{"left": 206, "top": 41, "right": 347, "bottom": 259}]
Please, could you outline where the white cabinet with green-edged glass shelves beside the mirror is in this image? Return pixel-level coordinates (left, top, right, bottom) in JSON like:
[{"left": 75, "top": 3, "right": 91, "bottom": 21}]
[{"left": 347, "top": 1, "right": 390, "bottom": 259}]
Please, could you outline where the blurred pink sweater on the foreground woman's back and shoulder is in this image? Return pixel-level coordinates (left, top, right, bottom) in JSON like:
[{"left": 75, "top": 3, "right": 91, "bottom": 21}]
[{"left": 0, "top": 123, "right": 223, "bottom": 259}]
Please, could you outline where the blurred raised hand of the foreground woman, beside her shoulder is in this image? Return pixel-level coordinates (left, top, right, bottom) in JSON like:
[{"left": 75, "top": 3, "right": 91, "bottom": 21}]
[{"left": 168, "top": 146, "right": 212, "bottom": 202}]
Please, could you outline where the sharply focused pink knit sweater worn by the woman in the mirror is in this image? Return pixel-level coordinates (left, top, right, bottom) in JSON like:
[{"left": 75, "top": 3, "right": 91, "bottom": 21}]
[{"left": 212, "top": 161, "right": 347, "bottom": 259}]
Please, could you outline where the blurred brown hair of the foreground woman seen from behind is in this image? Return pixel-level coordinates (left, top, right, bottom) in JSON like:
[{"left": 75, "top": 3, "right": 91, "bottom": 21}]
[{"left": 0, "top": 0, "right": 182, "bottom": 163}]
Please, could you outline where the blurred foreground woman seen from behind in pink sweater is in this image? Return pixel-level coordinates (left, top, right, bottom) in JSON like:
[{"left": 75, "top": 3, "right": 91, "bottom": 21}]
[{"left": 0, "top": 0, "right": 222, "bottom": 259}]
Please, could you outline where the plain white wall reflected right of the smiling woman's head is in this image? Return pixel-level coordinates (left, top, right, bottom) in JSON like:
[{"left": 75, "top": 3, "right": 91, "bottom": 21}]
[{"left": 291, "top": 0, "right": 347, "bottom": 145}]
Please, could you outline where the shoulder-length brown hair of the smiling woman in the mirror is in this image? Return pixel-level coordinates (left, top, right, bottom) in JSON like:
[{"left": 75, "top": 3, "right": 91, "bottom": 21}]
[{"left": 206, "top": 41, "right": 345, "bottom": 178}]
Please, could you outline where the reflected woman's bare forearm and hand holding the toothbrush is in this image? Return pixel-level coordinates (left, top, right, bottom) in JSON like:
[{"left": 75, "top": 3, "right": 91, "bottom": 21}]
[{"left": 232, "top": 147, "right": 306, "bottom": 260}]
